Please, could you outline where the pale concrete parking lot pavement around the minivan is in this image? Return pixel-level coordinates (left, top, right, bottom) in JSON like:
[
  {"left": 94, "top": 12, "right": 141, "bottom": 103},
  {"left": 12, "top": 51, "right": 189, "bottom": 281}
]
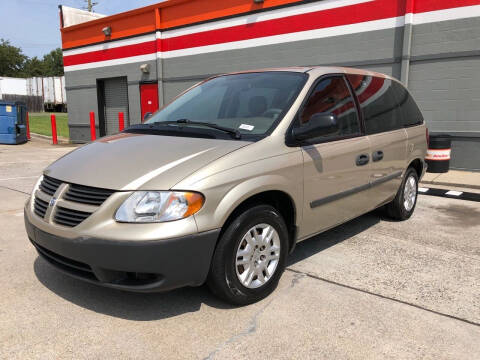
[{"left": 0, "top": 142, "right": 480, "bottom": 360}]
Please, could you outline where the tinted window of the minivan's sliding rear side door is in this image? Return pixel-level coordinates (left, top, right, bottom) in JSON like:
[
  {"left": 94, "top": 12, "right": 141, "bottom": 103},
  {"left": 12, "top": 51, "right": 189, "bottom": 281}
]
[{"left": 347, "top": 75, "right": 403, "bottom": 135}]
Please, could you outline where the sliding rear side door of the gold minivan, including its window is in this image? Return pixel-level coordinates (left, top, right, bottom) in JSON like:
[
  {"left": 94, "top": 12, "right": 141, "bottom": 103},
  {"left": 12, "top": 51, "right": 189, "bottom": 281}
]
[{"left": 347, "top": 75, "right": 407, "bottom": 207}]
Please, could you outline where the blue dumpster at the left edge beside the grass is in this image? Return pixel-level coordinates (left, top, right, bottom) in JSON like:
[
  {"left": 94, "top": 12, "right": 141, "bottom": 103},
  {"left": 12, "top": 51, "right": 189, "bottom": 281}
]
[{"left": 0, "top": 101, "right": 27, "bottom": 144}]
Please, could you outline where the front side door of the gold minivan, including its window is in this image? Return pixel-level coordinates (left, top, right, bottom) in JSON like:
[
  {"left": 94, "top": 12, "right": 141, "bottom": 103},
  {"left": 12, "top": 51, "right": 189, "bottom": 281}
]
[{"left": 295, "top": 75, "right": 370, "bottom": 239}]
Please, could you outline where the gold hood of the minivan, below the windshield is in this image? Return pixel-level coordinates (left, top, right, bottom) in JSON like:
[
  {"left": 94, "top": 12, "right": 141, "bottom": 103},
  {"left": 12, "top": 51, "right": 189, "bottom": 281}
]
[{"left": 44, "top": 133, "right": 251, "bottom": 190}]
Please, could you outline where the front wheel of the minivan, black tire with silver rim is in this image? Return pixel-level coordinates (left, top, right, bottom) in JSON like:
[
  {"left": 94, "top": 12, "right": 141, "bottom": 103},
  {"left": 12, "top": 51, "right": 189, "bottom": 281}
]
[{"left": 207, "top": 205, "right": 288, "bottom": 305}]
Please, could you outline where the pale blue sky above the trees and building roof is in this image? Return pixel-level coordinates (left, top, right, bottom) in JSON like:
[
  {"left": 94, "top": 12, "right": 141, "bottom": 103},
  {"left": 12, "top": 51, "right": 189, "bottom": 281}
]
[{"left": 0, "top": 0, "right": 160, "bottom": 58}]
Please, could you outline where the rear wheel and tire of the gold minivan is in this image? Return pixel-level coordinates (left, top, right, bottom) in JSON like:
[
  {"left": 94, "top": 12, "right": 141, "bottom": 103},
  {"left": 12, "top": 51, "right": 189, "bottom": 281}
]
[{"left": 386, "top": 168, "right": 418, "bottom": 220}]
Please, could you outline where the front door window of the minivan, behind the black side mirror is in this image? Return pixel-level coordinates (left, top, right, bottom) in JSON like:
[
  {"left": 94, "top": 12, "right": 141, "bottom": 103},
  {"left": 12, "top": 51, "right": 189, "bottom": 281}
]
[{"left": 299, "top": 76, "right": 360, "bottom": 142}]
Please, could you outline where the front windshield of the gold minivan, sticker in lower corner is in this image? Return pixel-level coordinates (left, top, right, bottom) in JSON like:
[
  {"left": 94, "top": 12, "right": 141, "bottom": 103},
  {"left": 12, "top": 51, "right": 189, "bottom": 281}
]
[{"left": 146, "top": 71, "right": 306, "bottom": 137}]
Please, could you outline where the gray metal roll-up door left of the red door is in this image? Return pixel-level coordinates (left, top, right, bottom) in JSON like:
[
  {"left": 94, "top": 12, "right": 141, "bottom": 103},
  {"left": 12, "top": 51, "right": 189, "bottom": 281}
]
[{"left": 104, "top": 77, "right": 129, "bottom": 135}]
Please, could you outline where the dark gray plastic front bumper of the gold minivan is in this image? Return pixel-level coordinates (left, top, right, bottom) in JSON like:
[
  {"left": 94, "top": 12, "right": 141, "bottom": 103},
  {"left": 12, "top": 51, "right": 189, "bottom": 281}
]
[{"left": 25, "top": 215, "right": 220, "bottom": 292}]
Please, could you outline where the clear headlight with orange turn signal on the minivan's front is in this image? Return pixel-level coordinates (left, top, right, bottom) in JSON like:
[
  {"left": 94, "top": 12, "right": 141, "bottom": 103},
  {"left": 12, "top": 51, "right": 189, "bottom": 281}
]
[{"left": 115, "top": 191, "right": 205, "bottom": 222}]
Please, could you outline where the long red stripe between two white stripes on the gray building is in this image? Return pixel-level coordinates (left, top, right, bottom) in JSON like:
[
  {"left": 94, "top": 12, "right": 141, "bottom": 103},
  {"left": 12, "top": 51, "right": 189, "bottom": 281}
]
[{"left": 64, "top": 0, "right": 480, "bottom": 66}]
